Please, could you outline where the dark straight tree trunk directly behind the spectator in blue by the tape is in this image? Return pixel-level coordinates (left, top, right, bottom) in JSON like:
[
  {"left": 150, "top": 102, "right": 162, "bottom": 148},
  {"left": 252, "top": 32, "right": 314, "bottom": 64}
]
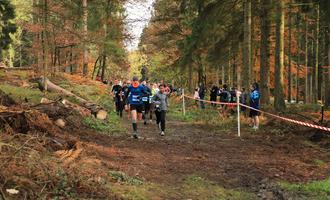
[{"left": 260, "top": 0, "right": 271, "bottom": 104}]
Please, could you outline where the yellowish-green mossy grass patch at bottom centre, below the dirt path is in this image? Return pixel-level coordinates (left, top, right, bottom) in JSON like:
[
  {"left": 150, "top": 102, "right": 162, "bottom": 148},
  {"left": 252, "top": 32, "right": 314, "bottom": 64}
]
[{"left": 110, "top": 175, "right": 257, "bottom": 200}]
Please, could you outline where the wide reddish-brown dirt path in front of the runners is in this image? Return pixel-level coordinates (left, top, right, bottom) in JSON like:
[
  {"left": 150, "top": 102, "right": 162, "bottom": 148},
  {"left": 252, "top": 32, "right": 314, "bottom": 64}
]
[{"left": 78, "top": 114, "right": 330, "bottom": 197}]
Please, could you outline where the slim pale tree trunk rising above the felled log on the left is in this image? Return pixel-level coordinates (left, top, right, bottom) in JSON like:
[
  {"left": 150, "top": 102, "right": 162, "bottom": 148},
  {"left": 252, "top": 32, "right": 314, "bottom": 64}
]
[{"left": 82, "top": 0, "right": 88, "bottom": 76}]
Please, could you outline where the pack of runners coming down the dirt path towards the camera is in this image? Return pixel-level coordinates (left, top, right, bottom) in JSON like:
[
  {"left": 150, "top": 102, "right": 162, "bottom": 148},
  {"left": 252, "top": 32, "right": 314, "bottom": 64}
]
[{"left": 111, "top": 76, "right": 171, "bottom": 139}]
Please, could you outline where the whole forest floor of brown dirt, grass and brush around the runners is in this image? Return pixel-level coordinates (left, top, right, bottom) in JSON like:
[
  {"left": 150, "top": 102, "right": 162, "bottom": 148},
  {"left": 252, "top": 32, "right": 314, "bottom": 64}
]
[{"left": 0, "top": 69, "right": 330, "bottom": 200}]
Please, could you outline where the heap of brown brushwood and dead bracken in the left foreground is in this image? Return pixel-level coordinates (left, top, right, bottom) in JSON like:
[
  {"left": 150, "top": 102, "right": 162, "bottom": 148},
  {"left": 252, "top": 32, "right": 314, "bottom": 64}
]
[{"left": 0, "top": 90, "right": 118, "bottom": 200}]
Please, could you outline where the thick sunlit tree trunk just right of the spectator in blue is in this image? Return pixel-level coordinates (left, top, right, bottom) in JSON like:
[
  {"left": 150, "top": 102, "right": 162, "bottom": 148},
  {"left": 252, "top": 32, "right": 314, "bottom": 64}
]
[{"left": 274, "top": 1, "right": 285, "bottom": 110}]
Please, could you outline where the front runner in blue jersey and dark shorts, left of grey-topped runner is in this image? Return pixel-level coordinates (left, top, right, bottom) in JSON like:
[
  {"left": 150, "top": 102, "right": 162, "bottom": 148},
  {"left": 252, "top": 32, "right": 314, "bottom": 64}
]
[{"left": 126, "top": 76, "right": 147, "bottom": 139}]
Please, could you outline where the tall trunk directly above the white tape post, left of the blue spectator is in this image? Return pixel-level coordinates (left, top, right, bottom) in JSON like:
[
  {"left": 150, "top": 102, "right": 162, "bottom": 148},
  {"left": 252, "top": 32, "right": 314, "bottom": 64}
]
[{"left": 238, "top": 0, "right": 251, "bottom": 88}]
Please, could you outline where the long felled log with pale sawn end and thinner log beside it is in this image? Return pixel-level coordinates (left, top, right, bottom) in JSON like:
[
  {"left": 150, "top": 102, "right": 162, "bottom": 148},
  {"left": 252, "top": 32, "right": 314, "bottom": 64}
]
[{"left": 37, "top": 77, "right": 107, "bottom": 120}]
